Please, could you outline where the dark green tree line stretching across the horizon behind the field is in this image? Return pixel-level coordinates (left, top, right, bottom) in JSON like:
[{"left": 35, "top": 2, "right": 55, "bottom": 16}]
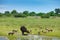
[{"left": 0, "top": 8, "right": 60, "bottom": 18}]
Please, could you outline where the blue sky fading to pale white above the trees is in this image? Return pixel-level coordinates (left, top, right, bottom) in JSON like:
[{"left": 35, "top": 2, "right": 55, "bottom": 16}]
[{"left": 0, "top": 0, "right": 60, "bottom": 12}]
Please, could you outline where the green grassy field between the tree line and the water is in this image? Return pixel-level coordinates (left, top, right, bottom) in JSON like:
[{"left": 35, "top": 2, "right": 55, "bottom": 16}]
[{"left": 0, "top": 17, "right": 60, "bottom": 37}]
